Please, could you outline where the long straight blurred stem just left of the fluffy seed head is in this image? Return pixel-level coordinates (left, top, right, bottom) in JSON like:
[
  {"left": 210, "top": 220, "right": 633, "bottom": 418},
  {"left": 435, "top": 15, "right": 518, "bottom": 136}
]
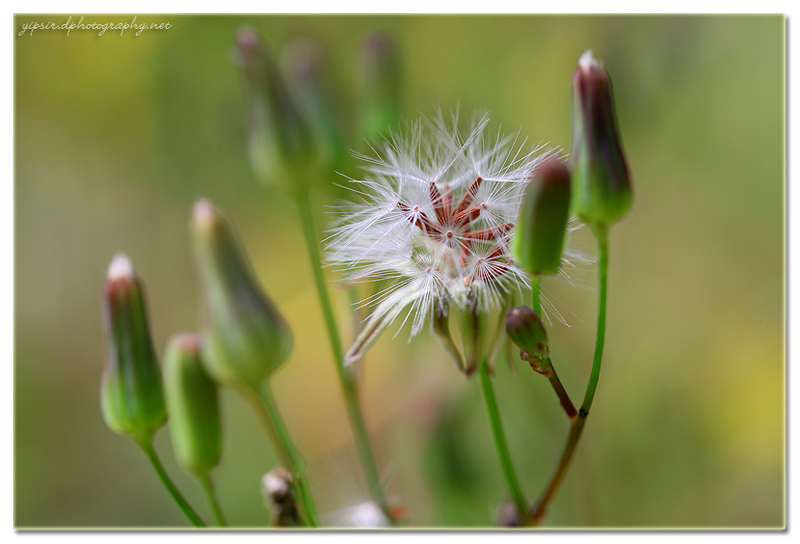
[{"left": 296, "top": 185, "right": 392, "bottom": 520}]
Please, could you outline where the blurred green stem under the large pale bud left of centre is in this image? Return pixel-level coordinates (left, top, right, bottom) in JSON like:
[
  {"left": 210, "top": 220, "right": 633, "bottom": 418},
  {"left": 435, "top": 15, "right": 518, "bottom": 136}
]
[{"left": 248, "top": 383, "right": 319, "bottom": 527}]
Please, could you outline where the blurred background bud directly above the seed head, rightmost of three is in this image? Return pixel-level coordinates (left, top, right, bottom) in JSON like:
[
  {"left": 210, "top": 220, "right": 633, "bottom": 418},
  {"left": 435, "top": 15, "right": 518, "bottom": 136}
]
[{"left": 361, "top": 32, "right": 401, "bottom": 141}]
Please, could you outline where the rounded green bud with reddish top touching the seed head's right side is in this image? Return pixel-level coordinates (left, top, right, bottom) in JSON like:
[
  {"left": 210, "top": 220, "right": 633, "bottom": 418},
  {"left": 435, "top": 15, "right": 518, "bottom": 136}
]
[{"left": 510, "top": 156, "right": 571, "bottom": 275}]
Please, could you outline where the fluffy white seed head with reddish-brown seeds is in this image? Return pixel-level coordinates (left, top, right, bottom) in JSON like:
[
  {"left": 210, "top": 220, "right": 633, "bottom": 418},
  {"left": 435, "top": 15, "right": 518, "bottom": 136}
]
[{"left": 328, "top": 113, "right": 580, "bottom": 360}]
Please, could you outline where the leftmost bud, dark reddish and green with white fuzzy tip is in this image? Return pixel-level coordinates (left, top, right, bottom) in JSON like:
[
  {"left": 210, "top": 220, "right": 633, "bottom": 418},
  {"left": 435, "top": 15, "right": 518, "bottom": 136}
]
[{"left": 101, "top": 254, "right": 167, "bottom": 447}]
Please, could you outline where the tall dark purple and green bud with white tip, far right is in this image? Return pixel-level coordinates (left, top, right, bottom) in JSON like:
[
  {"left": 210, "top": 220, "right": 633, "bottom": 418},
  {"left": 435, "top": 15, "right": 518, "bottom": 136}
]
[{"left": 570, "top": 51, "right": 631, "bottom": 227}]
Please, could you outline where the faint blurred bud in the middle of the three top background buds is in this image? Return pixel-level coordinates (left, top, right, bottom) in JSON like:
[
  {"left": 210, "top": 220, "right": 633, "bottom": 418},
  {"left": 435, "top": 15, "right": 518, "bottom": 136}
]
[{"left": 281, "top": 39, "right": 348, "bottom": 176}]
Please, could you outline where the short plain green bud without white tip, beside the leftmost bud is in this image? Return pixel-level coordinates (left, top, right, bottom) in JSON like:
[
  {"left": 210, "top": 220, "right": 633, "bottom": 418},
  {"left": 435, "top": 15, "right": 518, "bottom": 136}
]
[{"left": 164, "top": 332, "right": 222, "bottom": 476}]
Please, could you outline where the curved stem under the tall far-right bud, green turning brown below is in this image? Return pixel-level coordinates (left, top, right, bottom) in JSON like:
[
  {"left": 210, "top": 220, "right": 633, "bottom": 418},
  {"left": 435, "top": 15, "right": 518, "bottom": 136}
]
[{"left": 531, "top": 226, "right": 608, "bottom": 525}]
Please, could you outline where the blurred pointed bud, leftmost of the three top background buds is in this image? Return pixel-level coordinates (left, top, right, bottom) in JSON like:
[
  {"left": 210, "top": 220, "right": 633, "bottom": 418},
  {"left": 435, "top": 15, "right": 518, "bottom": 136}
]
[{"left": 236, "top": 27, "right": 315, "bottom": 182}]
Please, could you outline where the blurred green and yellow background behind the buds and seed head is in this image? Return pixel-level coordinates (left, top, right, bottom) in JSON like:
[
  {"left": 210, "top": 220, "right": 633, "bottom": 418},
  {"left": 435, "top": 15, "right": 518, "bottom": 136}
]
[{"left": 14, "top": 15, "right": 785, "bottom": 527}]
